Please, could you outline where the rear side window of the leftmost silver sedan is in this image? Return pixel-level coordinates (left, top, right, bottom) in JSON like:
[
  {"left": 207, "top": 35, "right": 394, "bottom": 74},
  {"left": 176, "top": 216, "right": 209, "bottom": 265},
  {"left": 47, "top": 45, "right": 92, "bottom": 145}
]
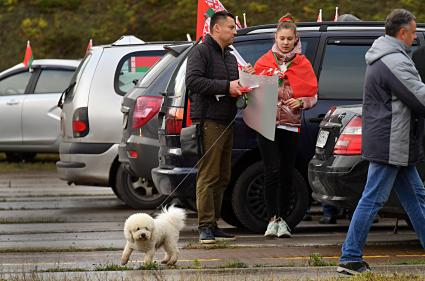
[{"left": 34, "top": 69, "right": 74, "bottom": 94}]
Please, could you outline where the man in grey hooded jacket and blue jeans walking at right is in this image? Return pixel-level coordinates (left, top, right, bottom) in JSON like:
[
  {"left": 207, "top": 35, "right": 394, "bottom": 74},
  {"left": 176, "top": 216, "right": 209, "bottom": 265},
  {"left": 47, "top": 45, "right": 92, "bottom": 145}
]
[{"left": 337, "top": 9, "right": 425, "bottom": 275}]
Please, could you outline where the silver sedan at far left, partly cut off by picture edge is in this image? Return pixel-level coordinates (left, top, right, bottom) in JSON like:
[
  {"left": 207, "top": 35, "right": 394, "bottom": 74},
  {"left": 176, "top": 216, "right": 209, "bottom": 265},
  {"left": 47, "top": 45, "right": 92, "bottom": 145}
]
[{"left": 0, "top": 59, "right": 79, "bottom": 161}]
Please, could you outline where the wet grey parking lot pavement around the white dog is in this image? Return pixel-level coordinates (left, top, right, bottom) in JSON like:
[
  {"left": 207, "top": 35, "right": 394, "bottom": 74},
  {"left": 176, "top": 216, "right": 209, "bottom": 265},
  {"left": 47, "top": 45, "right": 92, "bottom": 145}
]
[{"left": 0, "top": 161, "right": 425, "bottom": 280}]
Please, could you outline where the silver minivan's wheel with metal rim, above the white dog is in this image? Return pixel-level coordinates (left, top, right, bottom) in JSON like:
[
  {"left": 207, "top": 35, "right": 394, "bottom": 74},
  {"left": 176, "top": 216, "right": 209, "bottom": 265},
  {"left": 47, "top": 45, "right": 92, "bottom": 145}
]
[{"left": 115, "top": 165, "right": 168, "bottom": 209}]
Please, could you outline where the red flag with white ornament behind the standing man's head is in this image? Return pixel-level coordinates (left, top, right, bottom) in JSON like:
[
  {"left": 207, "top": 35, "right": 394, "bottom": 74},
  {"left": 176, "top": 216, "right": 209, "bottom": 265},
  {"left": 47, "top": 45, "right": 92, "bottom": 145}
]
[{"left": 196, "top": 0, "right": 241, "bottom": 40}]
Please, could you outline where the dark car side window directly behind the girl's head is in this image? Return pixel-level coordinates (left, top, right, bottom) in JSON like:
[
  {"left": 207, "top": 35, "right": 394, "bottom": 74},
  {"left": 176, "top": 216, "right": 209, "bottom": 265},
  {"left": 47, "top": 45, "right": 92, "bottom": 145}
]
[{"left": 233, "top": 37, "right": 318, "bottom": 65}]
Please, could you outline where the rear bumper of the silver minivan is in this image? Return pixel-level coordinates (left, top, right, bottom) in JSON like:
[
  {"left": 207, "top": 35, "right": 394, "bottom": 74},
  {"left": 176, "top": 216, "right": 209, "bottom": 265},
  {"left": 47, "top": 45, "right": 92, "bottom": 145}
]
[{"left": 56, "top": 142, "right": 118, "bottom": 186}]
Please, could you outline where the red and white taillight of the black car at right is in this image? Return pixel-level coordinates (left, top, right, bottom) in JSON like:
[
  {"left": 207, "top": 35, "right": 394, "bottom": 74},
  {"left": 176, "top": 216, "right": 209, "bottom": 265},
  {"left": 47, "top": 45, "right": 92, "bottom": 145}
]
[{"left": 334, "top": 116, "right": 362, "bottom": 155}]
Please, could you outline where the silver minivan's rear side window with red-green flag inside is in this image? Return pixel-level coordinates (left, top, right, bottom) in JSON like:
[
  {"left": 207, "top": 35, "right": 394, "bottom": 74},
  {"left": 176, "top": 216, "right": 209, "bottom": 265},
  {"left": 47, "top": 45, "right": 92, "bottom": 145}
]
[{"left": 114, "top": 51, "right": 165, "bottom": 95}]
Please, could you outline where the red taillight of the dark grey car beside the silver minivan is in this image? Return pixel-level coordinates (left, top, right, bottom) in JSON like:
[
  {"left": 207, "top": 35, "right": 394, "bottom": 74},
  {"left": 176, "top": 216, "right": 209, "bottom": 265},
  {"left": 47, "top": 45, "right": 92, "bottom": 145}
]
[{"left": 132, "top": 96, "right": 162, "bottom": 129}]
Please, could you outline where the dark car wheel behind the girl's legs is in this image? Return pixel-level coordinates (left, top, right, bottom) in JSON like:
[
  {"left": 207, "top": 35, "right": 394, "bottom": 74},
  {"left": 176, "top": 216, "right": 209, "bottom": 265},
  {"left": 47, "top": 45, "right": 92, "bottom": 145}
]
[{"left": 232, "top": 162, "right": 309, "bottom": 233}]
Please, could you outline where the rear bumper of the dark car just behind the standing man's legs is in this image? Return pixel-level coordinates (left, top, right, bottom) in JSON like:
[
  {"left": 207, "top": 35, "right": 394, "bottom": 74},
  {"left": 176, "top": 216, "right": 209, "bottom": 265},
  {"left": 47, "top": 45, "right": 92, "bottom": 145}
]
[{"left": 152, "top": 168, "right": 196, "bottom": 198}]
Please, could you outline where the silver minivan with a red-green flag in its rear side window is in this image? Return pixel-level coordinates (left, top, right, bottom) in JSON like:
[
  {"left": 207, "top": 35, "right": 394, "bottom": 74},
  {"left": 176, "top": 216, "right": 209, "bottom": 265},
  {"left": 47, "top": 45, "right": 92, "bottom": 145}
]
[{"left": 56, "top": 36, "right": 169, "bottom": 208}]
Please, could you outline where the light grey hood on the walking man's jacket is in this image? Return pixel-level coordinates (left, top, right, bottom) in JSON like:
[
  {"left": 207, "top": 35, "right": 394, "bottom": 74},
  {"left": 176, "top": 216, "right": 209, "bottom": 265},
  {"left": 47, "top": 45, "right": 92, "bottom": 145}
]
[{"left": 365, "top": 35, "right": 411, "bottom": 64}]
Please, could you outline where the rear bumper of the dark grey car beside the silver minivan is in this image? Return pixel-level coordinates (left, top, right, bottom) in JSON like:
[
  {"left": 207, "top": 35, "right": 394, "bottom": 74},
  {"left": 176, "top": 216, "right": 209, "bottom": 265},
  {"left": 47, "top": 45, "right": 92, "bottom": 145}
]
[{"left": 118, "top": 136, "right": 159, "bottom": 179}]
